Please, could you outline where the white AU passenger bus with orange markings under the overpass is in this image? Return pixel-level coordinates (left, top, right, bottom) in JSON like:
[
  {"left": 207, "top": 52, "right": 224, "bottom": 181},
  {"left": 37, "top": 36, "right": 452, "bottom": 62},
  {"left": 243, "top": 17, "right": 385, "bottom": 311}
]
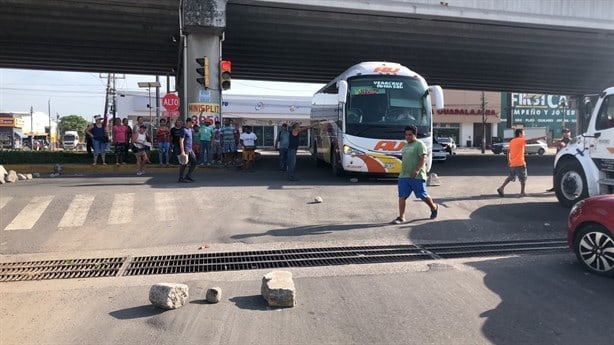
[{"left": 309, "top": 62, "right": 444, "bottom": 176}]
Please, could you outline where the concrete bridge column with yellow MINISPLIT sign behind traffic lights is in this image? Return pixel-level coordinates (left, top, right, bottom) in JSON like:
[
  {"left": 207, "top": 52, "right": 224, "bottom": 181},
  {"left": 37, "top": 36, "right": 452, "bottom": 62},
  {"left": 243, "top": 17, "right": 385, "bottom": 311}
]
[{"left": 180, "top": 0, "right": 227, "bottom": 123}]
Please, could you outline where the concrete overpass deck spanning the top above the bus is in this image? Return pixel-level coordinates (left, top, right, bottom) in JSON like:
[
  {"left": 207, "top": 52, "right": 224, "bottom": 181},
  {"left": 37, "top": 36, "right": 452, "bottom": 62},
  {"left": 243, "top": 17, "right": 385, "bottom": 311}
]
[{"left": 0, "top": 0, "right": 614, "bottom": 94}]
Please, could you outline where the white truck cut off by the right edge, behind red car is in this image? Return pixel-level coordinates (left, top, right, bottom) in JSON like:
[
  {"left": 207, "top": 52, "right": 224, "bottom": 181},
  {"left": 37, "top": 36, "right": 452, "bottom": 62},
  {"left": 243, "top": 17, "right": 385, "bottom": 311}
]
[{"left": 553, "top": 87, "right": 614, "bottom": 207}]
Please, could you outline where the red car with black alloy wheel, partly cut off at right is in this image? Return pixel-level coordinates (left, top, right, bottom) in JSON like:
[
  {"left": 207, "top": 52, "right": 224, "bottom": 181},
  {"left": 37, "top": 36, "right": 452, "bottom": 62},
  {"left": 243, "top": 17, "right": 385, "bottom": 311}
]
[{"left": 567, "top": 195, "right": 614, "bottom": 276}]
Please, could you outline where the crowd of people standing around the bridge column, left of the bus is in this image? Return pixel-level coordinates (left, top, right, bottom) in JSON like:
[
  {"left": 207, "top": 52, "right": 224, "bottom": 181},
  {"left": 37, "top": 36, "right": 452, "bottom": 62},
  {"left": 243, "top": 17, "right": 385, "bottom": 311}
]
[{"left": 85, "top": 115, "right": 257, "bottom": 177}]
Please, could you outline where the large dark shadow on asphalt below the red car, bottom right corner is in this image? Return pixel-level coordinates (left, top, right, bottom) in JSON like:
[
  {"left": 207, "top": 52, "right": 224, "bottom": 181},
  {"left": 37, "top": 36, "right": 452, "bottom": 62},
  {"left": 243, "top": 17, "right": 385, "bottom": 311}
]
[{"left": 468, "top": 253, "right": 614, "bottom": 345}]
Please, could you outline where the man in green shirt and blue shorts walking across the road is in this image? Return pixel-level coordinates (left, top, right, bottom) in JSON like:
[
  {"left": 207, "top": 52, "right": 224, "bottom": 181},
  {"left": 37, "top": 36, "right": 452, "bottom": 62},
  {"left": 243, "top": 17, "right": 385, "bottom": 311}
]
[{"left": 392, "top": 125, "right": 439, "bottom": 224}]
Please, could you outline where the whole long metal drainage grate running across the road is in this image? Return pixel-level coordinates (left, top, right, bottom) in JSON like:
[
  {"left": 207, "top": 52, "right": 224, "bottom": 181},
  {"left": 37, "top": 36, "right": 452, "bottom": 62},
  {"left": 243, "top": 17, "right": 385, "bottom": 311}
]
[{"left": 0, "top": 240, "right": 569, "bottom": 281}]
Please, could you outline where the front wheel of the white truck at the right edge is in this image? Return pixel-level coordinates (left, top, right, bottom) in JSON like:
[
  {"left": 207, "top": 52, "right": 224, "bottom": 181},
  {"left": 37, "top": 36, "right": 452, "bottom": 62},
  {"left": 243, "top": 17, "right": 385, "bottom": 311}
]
[{"left": 554, "top": 160, "right": 588, "bottom": 207}]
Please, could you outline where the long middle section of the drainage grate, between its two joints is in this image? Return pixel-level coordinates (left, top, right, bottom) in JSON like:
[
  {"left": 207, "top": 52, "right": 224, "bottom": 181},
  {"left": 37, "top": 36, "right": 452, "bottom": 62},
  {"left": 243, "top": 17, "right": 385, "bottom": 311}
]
[{"left": 124, "top": 245, "right": 434, "bottom": 276}]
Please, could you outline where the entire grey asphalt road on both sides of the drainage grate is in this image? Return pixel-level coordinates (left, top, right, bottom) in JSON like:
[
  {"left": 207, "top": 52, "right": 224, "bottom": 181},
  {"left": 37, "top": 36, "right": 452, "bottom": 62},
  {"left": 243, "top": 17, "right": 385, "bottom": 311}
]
[{"left": 0, "top": 150, "right": 614, "bottom": 344}]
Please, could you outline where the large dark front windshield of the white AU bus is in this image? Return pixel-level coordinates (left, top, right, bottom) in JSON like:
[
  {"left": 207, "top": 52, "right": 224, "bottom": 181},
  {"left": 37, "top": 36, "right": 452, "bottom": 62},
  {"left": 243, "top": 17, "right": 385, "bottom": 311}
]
[{"left": 345, "top": 75, "right": 431, "bottom": 139}]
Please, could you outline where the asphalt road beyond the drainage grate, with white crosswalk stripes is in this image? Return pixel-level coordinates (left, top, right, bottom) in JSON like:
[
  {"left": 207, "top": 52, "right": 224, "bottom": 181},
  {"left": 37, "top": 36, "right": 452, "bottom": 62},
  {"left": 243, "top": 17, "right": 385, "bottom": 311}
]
[{"left": 0, "top": 154, "right": 568, "bottom": 254}]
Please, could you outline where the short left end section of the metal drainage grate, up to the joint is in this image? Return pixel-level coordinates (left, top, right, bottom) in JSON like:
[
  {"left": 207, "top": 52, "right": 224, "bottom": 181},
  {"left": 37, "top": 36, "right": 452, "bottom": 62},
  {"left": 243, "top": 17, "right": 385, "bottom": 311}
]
[{"left": 0, "top": 258, "right": 125, "bottom": 281}]
